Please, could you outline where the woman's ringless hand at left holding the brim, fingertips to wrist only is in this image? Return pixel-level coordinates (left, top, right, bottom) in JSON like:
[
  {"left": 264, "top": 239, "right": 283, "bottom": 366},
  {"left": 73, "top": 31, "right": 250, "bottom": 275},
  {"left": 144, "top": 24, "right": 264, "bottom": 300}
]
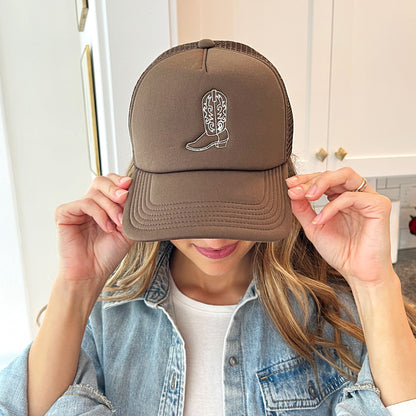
[{"left": 55, "top": 173, "right": 134, "bottom": 296}]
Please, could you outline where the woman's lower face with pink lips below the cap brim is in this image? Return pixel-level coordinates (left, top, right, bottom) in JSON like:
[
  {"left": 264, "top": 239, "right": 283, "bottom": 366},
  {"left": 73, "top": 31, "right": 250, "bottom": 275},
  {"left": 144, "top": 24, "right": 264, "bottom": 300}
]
[{"left": 171, "top": 239, "right": 255, "bottom": 276}]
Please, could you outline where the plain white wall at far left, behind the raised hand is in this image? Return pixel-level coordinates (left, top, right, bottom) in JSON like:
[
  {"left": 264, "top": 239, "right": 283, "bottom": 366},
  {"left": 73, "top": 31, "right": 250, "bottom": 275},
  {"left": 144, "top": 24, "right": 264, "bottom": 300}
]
[{"left": 0, "top": 0, "right": 91, "bottom": 335}]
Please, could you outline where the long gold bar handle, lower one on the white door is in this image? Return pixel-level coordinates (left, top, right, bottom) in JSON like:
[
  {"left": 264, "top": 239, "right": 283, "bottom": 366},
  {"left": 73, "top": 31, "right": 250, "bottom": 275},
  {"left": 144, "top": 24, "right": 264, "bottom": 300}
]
[{"left": 81, "top": 45, "right": 101, "bottom": 176}]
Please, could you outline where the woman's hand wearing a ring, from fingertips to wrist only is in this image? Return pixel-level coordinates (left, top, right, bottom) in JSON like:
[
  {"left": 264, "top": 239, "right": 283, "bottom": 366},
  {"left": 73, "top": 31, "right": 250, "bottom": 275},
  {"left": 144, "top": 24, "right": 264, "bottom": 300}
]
[{"left": 287, "top": 167, "right": 393, "bottom": 286}]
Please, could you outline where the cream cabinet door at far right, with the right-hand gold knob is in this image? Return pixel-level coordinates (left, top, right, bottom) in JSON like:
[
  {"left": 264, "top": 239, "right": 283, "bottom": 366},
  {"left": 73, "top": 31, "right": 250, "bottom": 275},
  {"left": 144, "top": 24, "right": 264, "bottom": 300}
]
[{"left": 327, "top": 0, "right": 416, "bottom": 176}]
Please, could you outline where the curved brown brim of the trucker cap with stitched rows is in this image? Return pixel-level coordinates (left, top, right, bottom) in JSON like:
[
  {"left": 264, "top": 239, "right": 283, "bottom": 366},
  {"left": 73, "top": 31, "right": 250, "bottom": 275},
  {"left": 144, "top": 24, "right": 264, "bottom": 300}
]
[{"left": 123, "top": 164, "right": 292, "bottom": 241}]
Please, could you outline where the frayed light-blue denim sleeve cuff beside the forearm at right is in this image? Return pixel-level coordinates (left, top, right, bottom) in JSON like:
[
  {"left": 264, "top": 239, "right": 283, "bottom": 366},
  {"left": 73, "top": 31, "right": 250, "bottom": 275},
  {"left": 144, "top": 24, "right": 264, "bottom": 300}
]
[{"left": 335, "top": 353, "right": 389, "bottom": 416}]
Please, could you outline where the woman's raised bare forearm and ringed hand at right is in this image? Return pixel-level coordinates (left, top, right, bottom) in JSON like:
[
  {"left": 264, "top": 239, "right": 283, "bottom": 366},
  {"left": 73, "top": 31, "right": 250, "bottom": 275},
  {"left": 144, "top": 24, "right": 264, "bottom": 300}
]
[{"left": 287, "top": 168, "right": 416, "bottom": 406}]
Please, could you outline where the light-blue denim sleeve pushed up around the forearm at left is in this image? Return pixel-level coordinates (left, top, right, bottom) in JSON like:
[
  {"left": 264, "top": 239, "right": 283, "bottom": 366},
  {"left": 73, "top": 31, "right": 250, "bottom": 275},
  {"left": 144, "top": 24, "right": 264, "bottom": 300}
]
[{"left": 0, "top": 327, "right": 115, "bottom": 416}]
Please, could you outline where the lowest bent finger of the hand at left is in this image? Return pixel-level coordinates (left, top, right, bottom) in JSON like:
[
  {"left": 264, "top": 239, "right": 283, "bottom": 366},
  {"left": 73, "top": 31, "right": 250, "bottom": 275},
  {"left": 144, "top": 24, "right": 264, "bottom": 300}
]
[{"left": 55, "top": 198, "right": 115, "bottom": 233}]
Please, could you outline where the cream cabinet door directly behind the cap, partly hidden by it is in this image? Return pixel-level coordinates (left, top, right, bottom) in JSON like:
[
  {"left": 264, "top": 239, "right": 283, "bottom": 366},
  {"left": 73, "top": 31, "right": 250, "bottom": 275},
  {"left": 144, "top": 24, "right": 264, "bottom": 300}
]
[{"left": 177, "top": 0, "right": 332, "bottom": 172}]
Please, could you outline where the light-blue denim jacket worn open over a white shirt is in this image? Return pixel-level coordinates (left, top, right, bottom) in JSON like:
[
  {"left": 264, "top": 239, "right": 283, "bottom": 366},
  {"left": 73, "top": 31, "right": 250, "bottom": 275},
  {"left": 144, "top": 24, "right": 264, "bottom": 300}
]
[{"left": 0, "top": 243, "right": 388, "bottom": 416}]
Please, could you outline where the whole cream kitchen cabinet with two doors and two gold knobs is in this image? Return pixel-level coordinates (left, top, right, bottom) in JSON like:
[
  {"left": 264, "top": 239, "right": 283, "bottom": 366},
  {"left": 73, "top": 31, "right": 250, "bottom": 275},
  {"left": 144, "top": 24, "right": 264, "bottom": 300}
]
[{"left": 177, "top": 0, "right": 416, "bottom": 176}]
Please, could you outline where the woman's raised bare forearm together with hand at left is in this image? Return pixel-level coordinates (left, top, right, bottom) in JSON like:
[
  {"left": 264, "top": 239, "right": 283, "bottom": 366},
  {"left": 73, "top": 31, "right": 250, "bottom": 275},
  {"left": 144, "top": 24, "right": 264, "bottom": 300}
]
[{"left": 27, "top": 174, "right": 133, "bottom": 415}]
